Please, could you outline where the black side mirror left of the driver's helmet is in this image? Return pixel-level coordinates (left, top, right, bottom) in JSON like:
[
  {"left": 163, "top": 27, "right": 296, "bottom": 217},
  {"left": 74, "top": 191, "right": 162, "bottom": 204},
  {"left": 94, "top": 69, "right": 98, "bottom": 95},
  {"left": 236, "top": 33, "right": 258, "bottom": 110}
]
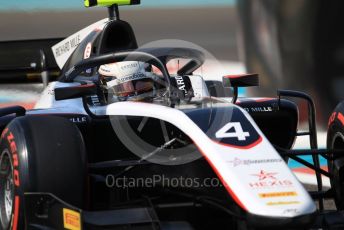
[{"left": 55, "top": 84, "right": 97, "bottom": 101}]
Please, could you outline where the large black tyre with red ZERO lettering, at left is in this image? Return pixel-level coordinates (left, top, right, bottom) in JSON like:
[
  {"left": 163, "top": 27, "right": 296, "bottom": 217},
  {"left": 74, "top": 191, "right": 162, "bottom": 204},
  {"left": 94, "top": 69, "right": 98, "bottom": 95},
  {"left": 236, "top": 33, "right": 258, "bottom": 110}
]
[{"left": 0, "top": 116, "right": 86, "bottom": 230}]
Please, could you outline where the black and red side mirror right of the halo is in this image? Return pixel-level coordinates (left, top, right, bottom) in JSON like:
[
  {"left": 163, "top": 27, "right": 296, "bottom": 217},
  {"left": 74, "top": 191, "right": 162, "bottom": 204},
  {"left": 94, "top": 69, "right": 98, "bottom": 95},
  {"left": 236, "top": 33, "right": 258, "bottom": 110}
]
[{"left": 222, "top": 74, "right": 259, "bottom": 88}]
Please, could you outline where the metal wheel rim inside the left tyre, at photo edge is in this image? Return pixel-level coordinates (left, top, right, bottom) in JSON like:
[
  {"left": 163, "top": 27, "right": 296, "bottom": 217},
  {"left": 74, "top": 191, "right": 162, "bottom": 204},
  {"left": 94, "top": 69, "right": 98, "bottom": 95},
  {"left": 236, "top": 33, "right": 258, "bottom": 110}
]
[{"left": 0, "top": 150, "right": 14, "bottom": 229}]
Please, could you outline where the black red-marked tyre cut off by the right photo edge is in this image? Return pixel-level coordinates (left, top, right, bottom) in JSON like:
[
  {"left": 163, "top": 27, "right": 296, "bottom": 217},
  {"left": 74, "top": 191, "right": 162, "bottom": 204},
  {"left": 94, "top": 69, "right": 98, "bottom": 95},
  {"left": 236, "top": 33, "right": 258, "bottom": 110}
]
[{"left": 327, "top": 102, "right": 344, "bottom": 210}]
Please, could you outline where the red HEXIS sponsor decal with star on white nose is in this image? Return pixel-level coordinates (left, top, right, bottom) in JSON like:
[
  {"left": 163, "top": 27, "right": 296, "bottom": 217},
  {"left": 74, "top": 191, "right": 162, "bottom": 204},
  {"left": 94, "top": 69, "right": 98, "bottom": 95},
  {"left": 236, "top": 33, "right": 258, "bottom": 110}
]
[{"left": 249, "top": 170, "right": 293, "bottom": 189}]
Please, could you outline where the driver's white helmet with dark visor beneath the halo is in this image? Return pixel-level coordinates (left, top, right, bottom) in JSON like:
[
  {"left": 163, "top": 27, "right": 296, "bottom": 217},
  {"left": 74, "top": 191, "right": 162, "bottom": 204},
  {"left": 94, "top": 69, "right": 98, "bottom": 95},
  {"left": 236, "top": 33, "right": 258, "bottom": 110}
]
[{"left": 98, "top": 61, "right": 155, "bottom": 101}]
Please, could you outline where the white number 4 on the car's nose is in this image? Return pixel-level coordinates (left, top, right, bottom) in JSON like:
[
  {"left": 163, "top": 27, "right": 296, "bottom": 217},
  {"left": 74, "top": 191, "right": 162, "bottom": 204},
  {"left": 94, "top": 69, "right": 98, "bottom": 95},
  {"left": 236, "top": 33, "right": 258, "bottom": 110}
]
[{"left": 215, "top": 122, "right": 250, "bottom": 141}]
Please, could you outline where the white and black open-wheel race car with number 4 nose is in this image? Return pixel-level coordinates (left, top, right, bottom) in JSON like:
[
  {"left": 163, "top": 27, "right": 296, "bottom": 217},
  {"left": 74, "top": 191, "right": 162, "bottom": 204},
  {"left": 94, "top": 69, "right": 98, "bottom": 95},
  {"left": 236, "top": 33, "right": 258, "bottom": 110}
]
[{"left": 0, "top": 0, "right": 344, "bottom": 230}]
